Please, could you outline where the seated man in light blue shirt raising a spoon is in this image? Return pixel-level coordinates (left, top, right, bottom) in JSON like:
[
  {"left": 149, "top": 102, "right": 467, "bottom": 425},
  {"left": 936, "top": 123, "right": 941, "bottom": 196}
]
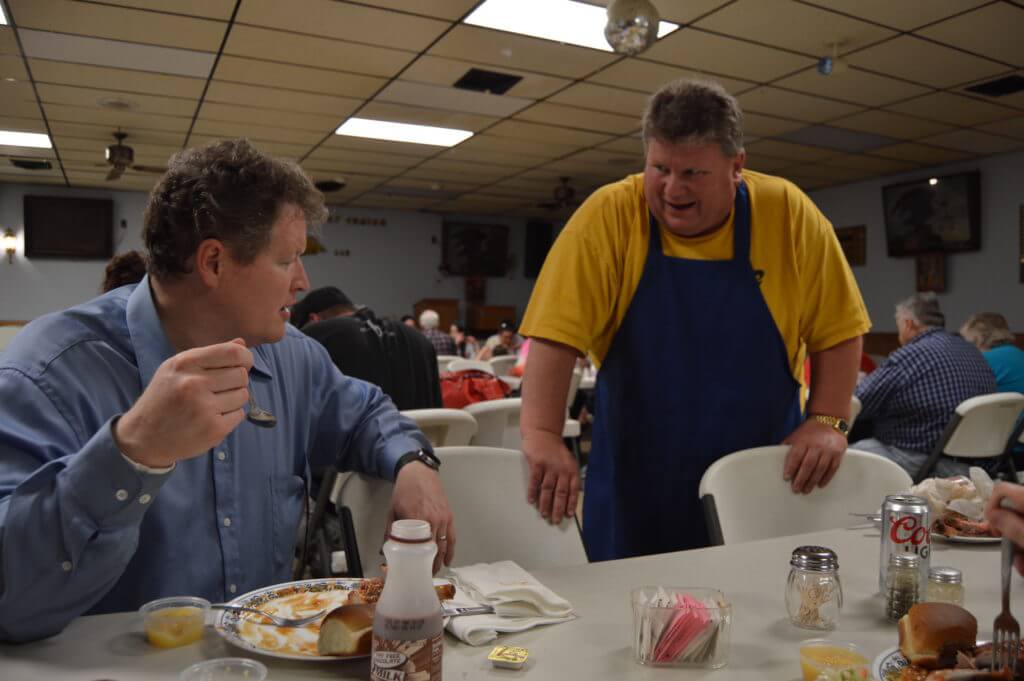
[{"left": 0, "top": 140, "right": 455, "bottom": 641}]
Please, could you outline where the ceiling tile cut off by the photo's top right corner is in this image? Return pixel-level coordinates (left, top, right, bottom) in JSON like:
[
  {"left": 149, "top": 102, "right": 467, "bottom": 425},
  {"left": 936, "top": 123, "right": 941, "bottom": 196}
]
[{"left": 919, "top": 2, "right": 1024, "bottom": 67}]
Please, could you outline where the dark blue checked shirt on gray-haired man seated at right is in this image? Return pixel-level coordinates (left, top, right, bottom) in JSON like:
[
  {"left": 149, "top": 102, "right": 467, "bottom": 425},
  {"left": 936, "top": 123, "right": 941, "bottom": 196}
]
[{"left": 855, "top": 329, "right": 995, "bottom": 454}]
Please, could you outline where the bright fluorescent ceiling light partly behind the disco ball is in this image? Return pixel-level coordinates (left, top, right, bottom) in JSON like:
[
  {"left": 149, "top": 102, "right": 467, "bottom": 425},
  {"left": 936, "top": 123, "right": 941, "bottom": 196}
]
[{"left": 465, "top": 0, "right": 679, "bottom": 52}]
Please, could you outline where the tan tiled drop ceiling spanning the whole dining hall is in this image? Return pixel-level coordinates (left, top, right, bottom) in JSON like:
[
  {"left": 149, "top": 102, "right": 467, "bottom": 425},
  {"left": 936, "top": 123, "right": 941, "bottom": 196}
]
[{"left": 0, "top": 0, "right": 1024, "bottom": 215}]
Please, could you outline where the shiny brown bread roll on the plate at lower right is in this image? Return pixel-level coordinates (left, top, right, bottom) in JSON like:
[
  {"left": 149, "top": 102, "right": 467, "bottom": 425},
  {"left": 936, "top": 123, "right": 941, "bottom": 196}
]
[{"left": 899, "top": 603, "right": 978, "bottom": 669}]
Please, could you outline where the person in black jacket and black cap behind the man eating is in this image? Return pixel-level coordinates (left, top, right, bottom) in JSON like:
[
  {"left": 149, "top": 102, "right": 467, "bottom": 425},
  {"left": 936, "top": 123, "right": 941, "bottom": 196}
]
[{"left": 292, "top": 286, "right": 441, "bottom": 411}]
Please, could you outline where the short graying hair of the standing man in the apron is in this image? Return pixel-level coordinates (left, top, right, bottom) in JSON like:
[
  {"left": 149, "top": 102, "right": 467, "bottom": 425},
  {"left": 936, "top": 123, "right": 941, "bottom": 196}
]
[{"left": 643, "top": 78, "right": 743, "bottom": 159}]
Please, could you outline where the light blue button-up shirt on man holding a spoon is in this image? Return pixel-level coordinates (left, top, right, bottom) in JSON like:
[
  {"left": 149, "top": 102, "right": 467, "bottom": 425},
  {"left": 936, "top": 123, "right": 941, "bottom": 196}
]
[{"left": 0, "top": 280, "right": 430, "bottom": 640}]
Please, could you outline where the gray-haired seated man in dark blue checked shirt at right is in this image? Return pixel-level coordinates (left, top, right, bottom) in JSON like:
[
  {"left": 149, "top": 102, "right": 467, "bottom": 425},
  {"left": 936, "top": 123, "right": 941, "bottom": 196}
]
[{"left": 850, "top": 294, "right": 995, "bottom": 477}]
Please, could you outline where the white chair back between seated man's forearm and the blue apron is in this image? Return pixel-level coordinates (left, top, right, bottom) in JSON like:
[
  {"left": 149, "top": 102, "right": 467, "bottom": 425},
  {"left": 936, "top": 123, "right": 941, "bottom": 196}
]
[{"left": 437, "top": 446, "right": 587, "bottom": 570}]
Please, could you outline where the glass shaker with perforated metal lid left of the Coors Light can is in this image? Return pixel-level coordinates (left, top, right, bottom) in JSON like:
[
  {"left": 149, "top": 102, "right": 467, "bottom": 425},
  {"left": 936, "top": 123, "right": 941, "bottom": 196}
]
[{"left": 785, "top": 546, "right": 843, "bottom": 630}]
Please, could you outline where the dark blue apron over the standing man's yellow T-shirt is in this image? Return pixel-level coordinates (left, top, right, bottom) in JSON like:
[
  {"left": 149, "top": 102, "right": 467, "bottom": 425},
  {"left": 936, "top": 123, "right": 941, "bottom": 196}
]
[{"left": 583, "top": 183, "right": 801, "bottom": 560}]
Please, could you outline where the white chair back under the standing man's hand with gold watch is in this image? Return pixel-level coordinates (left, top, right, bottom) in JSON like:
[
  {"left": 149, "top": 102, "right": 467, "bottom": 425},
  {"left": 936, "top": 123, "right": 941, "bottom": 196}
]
[{"left": 699, "top": 444, "right": 912, "bottom": 544}]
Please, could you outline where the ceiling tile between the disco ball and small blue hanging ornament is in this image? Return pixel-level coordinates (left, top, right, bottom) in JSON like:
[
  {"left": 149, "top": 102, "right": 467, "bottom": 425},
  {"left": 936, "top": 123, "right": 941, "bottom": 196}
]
[{"left": 644, "top": 29, "right": 814, "bottom": 82}]
